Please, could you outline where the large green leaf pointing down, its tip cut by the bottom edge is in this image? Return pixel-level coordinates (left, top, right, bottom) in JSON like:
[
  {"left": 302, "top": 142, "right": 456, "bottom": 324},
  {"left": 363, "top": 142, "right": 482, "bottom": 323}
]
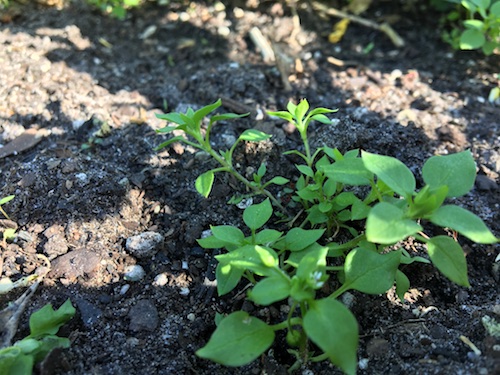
[{"left": 304, "top": 299, "right": 359, "bottom": 375}]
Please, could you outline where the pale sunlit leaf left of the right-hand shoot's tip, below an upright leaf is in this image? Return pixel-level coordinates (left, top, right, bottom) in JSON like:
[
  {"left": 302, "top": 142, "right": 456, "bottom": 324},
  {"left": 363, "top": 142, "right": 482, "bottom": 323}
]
[{"left": 366, "top": 202, "right": 422, "bottom": 245}]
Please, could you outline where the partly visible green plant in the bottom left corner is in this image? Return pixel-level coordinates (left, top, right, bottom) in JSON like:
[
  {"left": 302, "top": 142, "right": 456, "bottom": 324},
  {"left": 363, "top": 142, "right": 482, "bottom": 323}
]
[{"left": 0, "top": 300, "right": 75, "bottom": 375}]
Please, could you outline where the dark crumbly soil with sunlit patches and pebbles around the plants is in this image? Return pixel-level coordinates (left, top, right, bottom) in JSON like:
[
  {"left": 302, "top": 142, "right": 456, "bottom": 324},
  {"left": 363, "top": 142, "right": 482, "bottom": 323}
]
[{"left": 0, "top": 1, "right": 500, "bottom": 375}]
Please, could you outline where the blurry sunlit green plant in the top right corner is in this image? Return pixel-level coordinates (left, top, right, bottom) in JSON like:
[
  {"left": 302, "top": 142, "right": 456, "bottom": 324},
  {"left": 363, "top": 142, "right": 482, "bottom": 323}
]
[{"left": 440, "top": 0, "right": 500, "bottom": 55}]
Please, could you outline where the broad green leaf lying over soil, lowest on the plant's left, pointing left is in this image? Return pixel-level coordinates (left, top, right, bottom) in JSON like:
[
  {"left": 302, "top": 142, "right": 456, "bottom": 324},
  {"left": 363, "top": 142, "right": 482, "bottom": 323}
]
[{"left": 196, "top": 311, "right": 274, "bottom": 366}]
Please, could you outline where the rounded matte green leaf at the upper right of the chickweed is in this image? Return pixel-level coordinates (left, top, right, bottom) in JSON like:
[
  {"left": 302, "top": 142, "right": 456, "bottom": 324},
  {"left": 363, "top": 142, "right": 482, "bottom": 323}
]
[{"left": 422, "top": 151, "right": 476, "bottom": 197}]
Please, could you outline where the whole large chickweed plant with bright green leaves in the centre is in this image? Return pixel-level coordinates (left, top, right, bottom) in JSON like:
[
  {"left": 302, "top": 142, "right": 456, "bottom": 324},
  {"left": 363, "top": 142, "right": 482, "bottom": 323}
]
[{"left": 158, "top": 100, "right": 498, "bottom": 374}]
